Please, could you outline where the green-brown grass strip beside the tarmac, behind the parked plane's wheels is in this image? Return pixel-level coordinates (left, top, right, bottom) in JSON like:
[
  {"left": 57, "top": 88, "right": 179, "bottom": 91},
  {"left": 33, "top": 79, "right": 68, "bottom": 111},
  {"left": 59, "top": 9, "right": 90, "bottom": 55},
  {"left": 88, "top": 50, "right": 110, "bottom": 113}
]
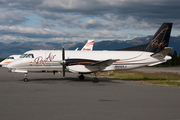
[{"left": 99, "top": 70, "right": 180, "bottom": 87}]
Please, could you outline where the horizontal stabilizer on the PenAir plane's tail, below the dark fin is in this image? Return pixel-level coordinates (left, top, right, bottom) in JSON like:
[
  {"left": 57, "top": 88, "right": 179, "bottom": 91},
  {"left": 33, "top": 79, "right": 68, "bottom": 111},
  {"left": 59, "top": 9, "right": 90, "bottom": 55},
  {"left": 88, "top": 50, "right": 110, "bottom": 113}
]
[{"left": 151, "top": 47, "right": 172, "bottom": 59}]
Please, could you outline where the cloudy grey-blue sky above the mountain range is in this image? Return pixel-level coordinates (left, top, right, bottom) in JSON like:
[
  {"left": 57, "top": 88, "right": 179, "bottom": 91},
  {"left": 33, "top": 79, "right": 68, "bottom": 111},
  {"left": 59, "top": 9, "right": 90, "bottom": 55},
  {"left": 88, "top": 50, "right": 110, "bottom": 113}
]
[{"left": 0, "top": 0, "right": 180, "bottom": 43}]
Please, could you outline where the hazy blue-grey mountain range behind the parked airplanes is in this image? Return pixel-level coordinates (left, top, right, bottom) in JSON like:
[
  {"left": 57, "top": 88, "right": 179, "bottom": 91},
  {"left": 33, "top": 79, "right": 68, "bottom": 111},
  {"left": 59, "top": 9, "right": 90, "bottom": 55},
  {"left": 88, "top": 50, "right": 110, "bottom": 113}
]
[{"left": 0, "top": 36, "right": 180, "bottom": 58}]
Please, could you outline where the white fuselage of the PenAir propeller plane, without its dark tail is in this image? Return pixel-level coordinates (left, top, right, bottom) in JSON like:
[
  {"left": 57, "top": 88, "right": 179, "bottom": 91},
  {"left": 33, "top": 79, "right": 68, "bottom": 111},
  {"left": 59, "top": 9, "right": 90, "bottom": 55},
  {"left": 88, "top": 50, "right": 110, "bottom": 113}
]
[{"left": 7, "top": 50, "right": 171, "bottom": 73}]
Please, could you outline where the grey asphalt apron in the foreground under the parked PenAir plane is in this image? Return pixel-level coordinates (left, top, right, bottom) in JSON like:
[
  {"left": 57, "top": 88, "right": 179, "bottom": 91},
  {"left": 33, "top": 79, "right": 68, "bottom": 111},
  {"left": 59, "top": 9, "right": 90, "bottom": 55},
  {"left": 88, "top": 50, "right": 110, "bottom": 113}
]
[{"left": 0, "top": 68, "right": 180, "bottom": 120}]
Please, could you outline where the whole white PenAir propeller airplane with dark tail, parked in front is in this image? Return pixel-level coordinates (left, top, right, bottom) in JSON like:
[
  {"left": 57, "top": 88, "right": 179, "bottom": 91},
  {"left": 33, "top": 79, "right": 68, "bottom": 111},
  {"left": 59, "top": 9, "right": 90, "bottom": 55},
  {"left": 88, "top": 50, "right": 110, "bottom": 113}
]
[{"left": 7, "top": 23, "right": 173, "bottom": 83}]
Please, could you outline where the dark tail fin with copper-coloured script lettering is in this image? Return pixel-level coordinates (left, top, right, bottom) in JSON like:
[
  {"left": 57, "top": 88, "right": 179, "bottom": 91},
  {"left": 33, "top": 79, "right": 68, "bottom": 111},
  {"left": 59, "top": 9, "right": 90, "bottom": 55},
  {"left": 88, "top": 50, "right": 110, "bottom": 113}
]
[{"left": 145, "top": 23, "right": 172, "bottom": 53}]
